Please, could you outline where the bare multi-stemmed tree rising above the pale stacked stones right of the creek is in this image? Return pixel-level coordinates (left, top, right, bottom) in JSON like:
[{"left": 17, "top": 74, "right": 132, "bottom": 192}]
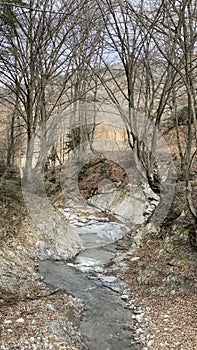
[{"left": 91, "top": 0, "right": 177, "bottom": 196}]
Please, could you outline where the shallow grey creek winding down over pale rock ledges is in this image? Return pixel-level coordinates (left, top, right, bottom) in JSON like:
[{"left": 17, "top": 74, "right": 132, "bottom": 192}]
[{"left": 39, "top": 203, "right": 138, "bottom": 350}]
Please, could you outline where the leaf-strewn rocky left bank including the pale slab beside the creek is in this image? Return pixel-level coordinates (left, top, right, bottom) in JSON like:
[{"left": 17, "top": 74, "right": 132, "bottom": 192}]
[{"left": 0, "top": 194, "right": 81, "bottom": 299}]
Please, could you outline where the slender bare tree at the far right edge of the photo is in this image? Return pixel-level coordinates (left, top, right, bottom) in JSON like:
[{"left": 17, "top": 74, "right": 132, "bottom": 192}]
[{"left": 139, "top": 0, "right": 197, "bottom": 222}]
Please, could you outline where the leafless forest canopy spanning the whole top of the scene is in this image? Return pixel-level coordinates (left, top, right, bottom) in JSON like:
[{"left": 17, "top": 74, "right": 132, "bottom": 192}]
[{"left": 0, "top": 0, "right": 197, "bottom": 220}]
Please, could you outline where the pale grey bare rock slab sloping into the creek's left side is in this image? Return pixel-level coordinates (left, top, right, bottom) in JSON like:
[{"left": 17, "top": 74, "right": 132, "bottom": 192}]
[{"left": 21, "top": 193, "right": 82, "bottom": 260}]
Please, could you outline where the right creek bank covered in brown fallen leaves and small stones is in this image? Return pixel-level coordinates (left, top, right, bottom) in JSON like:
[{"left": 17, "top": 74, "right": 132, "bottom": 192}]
[{"left": 115, "top": 221, "right": 197, "bottom": 350}]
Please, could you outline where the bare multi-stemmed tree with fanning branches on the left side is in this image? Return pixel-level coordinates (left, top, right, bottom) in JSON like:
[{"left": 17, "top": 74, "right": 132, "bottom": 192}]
[{"left": 0, "top": 0, "right": 96, "bottom": 176}]
